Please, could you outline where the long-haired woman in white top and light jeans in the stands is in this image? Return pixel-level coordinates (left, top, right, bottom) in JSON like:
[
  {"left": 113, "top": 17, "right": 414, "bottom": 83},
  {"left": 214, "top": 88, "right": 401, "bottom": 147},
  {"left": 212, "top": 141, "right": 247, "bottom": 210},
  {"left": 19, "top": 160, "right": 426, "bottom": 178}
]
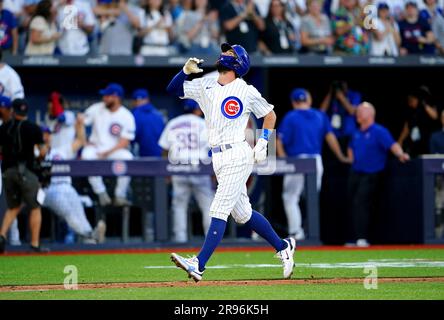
[{"left": 139, "top": 0, "right": 175, "bottom": 56}]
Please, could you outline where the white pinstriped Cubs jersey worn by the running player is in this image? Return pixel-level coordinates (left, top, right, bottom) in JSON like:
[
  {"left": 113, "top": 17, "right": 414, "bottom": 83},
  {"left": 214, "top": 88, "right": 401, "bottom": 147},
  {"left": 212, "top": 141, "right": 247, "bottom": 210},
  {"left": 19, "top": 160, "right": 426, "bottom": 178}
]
[{"left": 183, "top": 78, "right": 274, "bottom": 147}]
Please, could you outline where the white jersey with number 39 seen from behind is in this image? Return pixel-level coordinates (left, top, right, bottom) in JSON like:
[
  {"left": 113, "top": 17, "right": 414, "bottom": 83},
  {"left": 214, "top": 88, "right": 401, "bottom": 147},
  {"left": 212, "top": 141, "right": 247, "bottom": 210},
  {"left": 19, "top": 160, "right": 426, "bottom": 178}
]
[{"left": 159, "top": 114, "right": 209, "bottom": 164}]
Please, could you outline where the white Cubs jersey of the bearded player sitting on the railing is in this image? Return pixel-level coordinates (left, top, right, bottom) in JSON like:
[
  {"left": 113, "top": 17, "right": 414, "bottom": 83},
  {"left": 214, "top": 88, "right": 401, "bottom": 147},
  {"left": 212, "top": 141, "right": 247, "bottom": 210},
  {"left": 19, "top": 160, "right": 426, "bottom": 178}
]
[{"left": 85, "top": 102, "right": 136, "bottom": 151}]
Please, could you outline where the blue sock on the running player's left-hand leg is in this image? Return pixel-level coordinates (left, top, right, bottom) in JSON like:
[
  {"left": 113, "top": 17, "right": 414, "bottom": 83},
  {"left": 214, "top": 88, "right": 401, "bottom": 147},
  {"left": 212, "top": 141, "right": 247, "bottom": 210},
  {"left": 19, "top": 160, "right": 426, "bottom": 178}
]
[{"left": 197, "top": 218, "right": 227, "bottom": 272}]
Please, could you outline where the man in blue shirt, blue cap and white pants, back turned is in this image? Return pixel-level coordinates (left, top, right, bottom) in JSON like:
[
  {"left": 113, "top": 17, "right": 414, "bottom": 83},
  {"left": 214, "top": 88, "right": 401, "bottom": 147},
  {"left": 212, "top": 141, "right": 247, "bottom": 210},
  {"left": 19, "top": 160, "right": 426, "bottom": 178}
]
[{"left": 276, "top": 88, "right": 350, "bottom": 240}]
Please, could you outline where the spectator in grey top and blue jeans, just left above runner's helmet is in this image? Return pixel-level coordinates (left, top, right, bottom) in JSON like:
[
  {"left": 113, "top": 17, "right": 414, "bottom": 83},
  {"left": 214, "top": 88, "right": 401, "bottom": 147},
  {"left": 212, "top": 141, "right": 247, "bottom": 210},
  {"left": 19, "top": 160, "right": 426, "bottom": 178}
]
[{"left": 175, "top": 0, "right": 219, "bottom": 55}]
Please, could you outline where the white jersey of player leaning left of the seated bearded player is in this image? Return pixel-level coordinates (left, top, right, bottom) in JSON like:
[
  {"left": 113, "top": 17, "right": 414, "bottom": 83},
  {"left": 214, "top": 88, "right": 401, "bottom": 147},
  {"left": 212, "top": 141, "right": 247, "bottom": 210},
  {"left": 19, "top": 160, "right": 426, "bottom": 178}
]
[{"left": 45, "top": 111, "right": 76, "bottom": 160}]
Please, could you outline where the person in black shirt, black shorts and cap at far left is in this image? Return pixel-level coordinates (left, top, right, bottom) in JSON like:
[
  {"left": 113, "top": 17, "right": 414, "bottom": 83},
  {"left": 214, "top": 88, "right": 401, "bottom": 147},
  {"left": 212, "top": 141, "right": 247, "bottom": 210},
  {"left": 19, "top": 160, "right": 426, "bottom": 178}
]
[{"left": 0, "top": 99, "right": 48, "bottom": 253}]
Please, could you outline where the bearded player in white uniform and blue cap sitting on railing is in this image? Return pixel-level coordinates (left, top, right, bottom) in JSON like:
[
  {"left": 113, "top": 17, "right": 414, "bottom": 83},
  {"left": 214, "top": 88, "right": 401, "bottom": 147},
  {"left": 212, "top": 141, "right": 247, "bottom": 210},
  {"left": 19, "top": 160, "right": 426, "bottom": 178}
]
[{"left": 82, "top": 83, "right": 136, "bottom": 206}]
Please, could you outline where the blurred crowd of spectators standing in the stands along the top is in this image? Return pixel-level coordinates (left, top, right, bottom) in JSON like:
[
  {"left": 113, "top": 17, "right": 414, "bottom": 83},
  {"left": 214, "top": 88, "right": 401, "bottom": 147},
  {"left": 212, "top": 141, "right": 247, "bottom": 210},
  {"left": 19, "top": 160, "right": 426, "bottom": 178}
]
[{"left": 0, "top": 0, "right": 444, "bottom": 56}]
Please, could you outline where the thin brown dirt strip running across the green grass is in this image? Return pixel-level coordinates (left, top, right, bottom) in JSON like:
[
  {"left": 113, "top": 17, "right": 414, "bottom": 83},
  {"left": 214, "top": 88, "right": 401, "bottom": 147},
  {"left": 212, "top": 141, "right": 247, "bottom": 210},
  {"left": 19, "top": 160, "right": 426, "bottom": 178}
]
[{"left": 0, "top": 277, "right": 444, "bottom": 292}]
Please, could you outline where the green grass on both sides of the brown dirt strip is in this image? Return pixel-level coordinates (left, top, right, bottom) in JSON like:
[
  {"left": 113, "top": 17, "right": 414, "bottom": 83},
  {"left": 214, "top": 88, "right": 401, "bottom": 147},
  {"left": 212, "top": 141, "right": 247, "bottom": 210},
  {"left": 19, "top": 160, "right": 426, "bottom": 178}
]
[{"left": 0, "top": 249, "right": 444, "bottom": 299}]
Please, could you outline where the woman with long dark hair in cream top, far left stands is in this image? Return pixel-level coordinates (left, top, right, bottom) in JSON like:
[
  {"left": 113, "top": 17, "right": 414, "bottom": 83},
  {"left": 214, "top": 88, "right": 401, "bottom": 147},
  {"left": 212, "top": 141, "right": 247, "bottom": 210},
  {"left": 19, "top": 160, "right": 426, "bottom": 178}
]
[{"left": 25, "top": 0, "right": 61, "bottom": 55}]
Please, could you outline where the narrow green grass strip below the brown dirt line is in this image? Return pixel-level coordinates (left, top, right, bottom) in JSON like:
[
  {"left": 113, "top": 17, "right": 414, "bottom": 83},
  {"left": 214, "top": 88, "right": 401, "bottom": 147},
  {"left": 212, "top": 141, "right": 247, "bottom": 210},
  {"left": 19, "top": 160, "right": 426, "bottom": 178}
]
[{"left": 0, "top": 283, "right": 444, "bottom": 300}]
